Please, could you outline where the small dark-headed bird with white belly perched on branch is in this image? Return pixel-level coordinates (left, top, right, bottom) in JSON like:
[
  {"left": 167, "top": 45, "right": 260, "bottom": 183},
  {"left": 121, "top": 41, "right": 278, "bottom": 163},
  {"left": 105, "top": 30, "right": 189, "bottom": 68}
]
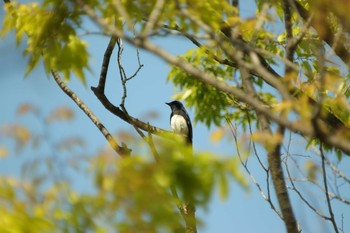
[{"left": 166, "top": 100, "right": 192, "bottom": 145}]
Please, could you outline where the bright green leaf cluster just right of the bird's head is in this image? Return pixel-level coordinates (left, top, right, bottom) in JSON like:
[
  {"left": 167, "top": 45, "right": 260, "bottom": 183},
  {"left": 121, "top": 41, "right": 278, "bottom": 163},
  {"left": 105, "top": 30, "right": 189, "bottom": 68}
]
[{"left": 168, "top": 49, "right": 233, "bottom": 127}]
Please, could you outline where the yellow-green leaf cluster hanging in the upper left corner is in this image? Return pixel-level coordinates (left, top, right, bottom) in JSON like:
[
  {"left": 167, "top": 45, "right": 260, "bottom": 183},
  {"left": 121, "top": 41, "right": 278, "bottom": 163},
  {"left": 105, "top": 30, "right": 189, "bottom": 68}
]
[{"left": 0, "top": 1, "right": 89, "bottom": 83}]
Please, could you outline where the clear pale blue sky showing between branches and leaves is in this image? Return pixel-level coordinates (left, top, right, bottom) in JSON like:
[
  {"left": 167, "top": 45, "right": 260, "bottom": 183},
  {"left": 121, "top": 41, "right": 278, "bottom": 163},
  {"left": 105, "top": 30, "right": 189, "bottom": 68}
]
[{"left": 0, "top": 0, "right": 350, "bottom": 233}]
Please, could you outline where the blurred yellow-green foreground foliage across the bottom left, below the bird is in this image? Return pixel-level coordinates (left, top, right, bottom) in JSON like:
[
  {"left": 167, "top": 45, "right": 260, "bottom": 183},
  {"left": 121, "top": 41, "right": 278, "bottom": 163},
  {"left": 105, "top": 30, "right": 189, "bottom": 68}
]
[{"left": 0, "top": 104, "right": 247, "bottom": 232}]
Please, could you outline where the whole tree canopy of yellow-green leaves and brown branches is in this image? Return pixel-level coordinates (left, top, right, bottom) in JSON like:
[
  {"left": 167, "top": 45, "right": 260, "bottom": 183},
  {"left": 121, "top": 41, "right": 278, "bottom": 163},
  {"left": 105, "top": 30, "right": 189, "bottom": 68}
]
[{"left": 0, "top": 0, "right": 350, "bottom": 233}]
